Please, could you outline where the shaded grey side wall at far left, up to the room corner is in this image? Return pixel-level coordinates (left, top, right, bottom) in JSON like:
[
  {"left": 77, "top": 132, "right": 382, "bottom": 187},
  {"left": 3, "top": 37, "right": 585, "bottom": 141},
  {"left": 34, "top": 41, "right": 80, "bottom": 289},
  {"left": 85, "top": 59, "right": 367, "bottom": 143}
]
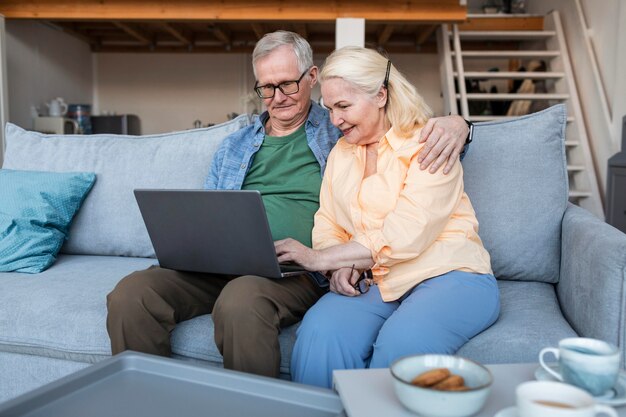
[{"left": 6, "top": 20, "right": 92, "bottom": 129}]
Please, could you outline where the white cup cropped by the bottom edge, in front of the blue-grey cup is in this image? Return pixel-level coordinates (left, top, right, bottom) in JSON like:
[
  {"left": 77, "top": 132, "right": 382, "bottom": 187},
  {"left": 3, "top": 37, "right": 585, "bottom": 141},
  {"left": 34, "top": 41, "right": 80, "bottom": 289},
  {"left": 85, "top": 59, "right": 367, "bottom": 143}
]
[{"left": 515, "top": 381, "right": 618, "bottom": 417}]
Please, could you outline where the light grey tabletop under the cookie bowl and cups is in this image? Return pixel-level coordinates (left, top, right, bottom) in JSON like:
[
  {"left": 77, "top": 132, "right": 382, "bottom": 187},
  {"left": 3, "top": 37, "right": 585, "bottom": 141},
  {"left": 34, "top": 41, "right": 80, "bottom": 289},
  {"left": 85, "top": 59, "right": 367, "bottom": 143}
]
[{"left": 333, "top": 363, "right": 626, "bottom": 417}]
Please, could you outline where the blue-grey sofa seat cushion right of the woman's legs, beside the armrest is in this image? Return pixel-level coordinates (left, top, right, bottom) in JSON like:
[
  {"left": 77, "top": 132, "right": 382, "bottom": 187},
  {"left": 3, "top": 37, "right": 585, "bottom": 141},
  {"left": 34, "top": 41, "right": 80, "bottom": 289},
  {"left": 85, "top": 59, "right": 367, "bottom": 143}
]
[{"left": 457, "top": 280, "right": 578, "bottom": 363}]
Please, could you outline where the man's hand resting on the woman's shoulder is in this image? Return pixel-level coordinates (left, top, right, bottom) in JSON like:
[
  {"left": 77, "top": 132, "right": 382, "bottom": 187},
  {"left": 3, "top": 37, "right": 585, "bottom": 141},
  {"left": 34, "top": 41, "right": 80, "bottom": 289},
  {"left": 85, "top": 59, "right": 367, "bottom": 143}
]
[{"left": 417, "top": 116, "right": 469, "bottom": 174}]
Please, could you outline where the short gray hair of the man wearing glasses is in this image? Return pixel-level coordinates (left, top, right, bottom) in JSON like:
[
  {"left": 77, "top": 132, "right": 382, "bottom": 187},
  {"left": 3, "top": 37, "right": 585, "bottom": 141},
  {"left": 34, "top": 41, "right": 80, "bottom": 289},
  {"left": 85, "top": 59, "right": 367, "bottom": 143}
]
[{"left": 252, "top": 30, "right": 313, "bottom": 78}]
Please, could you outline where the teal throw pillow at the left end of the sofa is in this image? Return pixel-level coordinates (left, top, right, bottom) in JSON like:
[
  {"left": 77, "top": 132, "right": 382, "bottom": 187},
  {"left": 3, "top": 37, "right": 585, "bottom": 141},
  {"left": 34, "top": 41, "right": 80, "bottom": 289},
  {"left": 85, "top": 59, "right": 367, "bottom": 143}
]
[{"left": 0, "top": 169, "right": 96, "bottom": 273}]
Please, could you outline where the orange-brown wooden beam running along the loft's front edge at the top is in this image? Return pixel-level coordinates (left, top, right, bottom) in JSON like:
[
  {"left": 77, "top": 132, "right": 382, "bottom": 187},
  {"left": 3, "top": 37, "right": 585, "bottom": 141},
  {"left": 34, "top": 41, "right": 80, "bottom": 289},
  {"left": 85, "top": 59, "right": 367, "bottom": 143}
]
[{"left": 0, "top": 0, "right": 467, "bottom": 23}]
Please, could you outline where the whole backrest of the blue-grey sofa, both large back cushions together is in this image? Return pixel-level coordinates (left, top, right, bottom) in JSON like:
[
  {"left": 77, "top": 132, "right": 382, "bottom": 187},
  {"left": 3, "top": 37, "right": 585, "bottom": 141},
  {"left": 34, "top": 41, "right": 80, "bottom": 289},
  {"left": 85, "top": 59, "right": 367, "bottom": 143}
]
[{"left": 3, "top": 105, "right": 568, "bottom": 282}]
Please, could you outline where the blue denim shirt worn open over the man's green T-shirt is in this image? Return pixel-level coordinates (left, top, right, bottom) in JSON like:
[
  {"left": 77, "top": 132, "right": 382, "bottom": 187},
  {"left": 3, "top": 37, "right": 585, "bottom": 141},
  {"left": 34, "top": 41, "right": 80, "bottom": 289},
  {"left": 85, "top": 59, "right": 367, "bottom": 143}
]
[{"left": 204, "top": 101, "right": 342, "bottom": 190}]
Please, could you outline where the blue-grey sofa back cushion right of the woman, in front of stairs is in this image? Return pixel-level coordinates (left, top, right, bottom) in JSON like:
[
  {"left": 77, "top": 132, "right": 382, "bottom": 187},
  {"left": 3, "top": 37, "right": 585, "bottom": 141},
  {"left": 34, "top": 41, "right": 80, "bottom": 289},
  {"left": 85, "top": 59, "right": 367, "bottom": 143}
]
[{"left": 463, "top": 104, "right": 568, "bottom": 282}]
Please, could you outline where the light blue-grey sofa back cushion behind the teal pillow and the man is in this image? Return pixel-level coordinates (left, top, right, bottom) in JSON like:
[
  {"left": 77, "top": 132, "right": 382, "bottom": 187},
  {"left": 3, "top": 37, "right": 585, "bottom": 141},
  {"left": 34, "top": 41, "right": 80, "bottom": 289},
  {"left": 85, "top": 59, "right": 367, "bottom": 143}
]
[{"left": 4, "top": 115, "right": 250, "bottom": 257}]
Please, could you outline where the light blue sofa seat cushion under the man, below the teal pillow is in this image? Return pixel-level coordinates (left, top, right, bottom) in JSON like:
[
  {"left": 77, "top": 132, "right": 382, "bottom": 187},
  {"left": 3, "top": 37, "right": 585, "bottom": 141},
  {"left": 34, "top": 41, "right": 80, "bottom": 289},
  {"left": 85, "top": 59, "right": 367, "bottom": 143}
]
[{"left": 0, "top": 255, "right": 297, "bottom": 374}]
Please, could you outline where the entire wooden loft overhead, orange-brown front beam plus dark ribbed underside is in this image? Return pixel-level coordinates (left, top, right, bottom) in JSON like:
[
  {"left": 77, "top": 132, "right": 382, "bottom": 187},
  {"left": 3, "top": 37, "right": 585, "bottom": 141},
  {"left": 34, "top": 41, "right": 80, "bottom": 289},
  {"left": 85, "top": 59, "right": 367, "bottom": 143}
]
[{"left": 0, "top": 0, "right": 467, "bottom": 53}]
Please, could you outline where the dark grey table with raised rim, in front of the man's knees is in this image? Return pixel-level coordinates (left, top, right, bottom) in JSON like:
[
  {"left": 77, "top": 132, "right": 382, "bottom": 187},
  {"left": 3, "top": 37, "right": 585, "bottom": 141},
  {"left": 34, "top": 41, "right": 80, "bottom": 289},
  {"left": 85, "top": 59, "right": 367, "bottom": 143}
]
[{"left": 0, "top": 352, "right": 345, "bottom": 417}]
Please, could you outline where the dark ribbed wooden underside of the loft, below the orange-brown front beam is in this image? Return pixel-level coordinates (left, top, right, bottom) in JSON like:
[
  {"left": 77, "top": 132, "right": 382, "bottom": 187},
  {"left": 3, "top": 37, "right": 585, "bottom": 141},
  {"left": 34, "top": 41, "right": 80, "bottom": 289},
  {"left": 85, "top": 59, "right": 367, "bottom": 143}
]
[{"left": 39, "top": 20, "right": 444, "bottom": 53}]
